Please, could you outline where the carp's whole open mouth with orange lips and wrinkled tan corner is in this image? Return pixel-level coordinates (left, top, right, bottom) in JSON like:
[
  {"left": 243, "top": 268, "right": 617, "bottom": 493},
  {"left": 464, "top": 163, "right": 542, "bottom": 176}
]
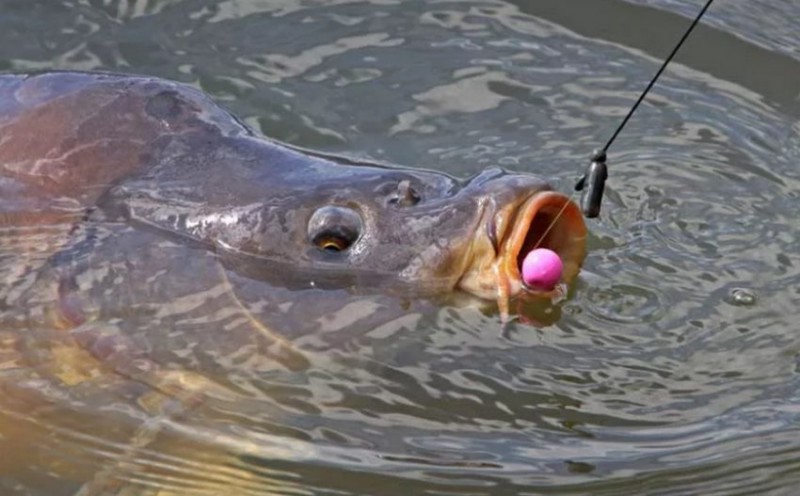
[{"left": 459, "top": 191, "right": 586, "bottom": 314}]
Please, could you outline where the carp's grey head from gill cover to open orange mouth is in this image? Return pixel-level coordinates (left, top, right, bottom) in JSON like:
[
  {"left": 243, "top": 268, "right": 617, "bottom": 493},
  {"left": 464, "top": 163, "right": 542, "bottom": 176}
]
[{"left": 133, "top": 140, "right": 586, "bottom": 299}]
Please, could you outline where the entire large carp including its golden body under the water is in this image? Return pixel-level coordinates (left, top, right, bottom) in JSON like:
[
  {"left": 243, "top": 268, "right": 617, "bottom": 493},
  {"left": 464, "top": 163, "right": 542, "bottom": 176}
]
[{"left": 0, "top": 72, "right": 586, "bottom": 494}]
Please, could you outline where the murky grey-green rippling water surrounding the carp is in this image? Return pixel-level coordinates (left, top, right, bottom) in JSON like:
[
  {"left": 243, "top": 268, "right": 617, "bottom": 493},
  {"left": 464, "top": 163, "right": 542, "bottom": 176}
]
[{"left": 0, "top": 0, "right": 800, "bottom": 496}]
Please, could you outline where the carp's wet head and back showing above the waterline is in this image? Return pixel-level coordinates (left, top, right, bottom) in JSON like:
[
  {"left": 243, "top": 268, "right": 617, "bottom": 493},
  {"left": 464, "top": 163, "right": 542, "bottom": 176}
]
[{"left": 0, "top": 72, "right": 586, "bottom": 314}]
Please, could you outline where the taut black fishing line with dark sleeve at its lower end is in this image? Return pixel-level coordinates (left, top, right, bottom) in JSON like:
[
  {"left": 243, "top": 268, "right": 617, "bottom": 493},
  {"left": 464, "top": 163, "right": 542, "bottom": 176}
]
[{"left": 575, "top": 0, "right": 714, "bottom": 218}]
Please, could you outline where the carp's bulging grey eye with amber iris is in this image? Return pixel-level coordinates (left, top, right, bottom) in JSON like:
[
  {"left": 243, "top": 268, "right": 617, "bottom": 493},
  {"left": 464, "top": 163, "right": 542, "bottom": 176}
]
[{"left": 308, "top": 205, "right": 362, "bottom": 252}]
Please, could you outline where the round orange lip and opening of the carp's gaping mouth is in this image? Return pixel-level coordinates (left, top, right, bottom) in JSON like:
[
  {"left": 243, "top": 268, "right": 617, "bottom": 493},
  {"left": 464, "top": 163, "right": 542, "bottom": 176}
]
[{"left": 493, "top": 190, "right": 586, "bottom": 296}]
